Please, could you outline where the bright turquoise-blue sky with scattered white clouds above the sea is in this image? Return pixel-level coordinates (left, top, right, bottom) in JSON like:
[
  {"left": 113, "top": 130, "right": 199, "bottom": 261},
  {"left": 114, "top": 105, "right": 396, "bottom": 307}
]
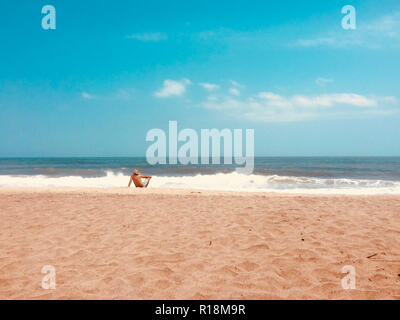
[{"left": 0, "top": 0, "right": 400, "bottom": 157}]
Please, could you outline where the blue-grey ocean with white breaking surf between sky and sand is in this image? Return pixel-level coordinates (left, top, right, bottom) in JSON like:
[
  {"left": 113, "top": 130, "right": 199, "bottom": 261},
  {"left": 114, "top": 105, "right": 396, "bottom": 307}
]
[{"left": 0, "top": 157, "right": 400, "bottom": 194}]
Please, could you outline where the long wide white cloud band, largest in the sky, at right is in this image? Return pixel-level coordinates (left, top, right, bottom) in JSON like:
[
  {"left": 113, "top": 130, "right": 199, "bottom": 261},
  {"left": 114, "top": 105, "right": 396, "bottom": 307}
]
[{"left": 203, "top": 92, "right": 400, "bottom": 122}]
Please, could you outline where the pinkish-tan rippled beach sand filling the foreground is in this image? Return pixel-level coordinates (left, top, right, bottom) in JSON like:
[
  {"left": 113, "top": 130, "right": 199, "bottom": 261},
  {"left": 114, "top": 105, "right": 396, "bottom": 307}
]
[{"left": 0, "top": 188, "right": 400, "bottom": 299}]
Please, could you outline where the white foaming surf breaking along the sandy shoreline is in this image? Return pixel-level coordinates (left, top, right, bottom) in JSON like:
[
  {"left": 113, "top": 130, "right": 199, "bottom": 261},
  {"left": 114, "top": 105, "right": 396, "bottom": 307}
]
[{"left": 0, "top": 172, "right": 400, "bottom": 194}]
